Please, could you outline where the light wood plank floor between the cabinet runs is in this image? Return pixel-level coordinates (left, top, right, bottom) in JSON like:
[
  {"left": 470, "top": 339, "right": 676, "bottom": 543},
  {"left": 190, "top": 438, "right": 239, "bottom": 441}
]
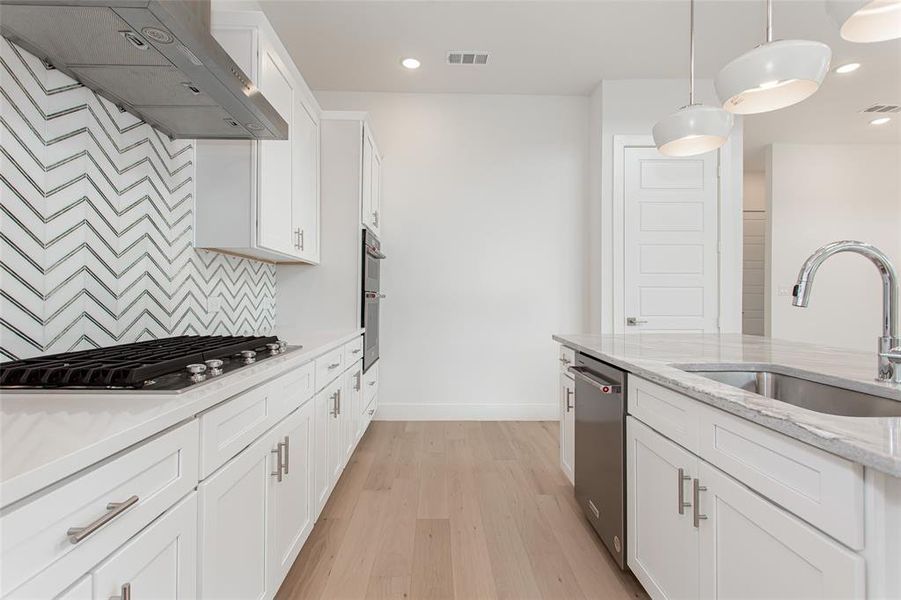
[{"left": 278, "top": 421, "right": 647, "bottom": 600}]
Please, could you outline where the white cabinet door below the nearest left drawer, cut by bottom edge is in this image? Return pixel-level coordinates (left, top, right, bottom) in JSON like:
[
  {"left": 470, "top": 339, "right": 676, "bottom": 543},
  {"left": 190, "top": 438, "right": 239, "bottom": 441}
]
[{"left": 94, "top": 492, "right": 197, "bottom": 600}]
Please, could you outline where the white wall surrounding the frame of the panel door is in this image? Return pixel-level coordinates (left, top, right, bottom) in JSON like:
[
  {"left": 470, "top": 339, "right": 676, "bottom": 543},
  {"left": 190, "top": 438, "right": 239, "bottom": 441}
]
[{"left": 590, "top": 79, "right": 742, "bottom": 333}]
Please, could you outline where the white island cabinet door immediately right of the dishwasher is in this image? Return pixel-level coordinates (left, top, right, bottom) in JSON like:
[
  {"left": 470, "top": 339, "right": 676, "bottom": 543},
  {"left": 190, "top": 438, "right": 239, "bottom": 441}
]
[{"left": 626, "top": 417, "right": 700, "bottom": 600}]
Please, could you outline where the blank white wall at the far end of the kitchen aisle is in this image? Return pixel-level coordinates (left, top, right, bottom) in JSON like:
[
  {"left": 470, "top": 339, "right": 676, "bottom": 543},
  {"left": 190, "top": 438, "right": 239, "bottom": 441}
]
[{"left": 317, "top": 92, "right": 588, "bottom": 419}]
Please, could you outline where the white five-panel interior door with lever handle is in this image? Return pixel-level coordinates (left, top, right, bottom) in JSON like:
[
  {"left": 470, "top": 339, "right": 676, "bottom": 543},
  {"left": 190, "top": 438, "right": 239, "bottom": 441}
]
[{"left": 618, "top": 147, "right": 719, "bottom": 332}]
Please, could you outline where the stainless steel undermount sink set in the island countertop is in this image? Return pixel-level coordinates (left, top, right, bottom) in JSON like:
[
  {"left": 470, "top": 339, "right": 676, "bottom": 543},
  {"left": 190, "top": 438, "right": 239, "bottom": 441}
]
[{"left": 682, "top": 367, "right": 901, "bottom": 417}]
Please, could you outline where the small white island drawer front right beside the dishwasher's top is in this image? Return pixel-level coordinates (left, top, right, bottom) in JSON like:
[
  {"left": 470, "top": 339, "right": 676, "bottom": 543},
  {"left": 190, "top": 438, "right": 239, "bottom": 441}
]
[{"left": 627, "top": 375, "right": 701, "bottom": 453}]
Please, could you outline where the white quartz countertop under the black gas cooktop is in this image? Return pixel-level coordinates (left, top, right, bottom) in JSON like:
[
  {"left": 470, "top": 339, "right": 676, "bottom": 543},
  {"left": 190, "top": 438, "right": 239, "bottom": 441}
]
[{"left": 0, "top": 329, "right": 363, "bottom": 506}]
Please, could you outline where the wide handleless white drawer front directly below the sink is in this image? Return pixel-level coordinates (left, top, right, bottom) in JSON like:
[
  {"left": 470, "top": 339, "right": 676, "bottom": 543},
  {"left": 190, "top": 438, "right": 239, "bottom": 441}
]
[{"left": 698, "top": 405, "right": 864, "bottom": 550}]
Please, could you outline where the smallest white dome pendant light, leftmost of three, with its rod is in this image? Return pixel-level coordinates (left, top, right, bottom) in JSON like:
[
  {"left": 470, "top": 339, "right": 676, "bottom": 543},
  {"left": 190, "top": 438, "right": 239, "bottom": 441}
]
[{"left": 653, "top": 0, "right": 734, "bottom": 156}]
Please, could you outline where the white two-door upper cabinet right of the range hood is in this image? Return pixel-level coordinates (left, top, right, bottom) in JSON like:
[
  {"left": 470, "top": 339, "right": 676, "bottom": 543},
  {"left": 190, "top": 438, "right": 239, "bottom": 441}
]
[{"left": 195, "top": 10, "right": 320, "bottom": 263}]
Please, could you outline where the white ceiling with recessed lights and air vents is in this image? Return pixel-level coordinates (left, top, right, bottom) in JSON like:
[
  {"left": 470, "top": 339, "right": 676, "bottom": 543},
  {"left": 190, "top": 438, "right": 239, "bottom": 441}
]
[{"left": 259, "top": 0, "right": 901, "bottom": 170}]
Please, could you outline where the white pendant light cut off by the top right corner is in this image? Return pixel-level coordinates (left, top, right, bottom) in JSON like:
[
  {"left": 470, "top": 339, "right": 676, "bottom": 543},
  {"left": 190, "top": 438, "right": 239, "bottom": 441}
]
[{"left": 826, "top": 0, "right": 901, "bottom": 43}]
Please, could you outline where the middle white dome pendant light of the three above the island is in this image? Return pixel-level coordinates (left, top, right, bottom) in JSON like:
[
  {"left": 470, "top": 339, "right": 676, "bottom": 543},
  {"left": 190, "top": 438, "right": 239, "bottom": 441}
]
[{"left": 713, "top": 0, "right": 832, "bottom": 115}]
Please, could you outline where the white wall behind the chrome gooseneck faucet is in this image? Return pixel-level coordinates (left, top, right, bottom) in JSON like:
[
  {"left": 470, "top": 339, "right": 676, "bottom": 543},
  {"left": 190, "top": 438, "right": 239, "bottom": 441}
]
[{"left": 767, "top": 144, "right": 901, "bottom": 351}]
